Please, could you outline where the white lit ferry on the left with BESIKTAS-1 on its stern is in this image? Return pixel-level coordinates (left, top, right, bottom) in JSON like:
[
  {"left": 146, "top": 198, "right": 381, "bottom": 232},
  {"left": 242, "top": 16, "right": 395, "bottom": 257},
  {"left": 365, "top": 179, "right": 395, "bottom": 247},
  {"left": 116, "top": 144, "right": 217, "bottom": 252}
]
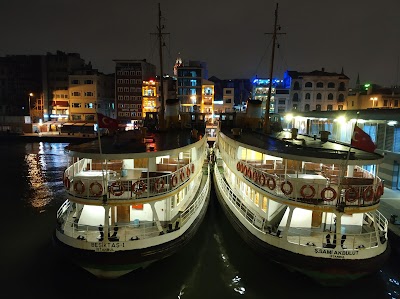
[{"left": 54, "top": 122, "right": 211, "bottom": 278}]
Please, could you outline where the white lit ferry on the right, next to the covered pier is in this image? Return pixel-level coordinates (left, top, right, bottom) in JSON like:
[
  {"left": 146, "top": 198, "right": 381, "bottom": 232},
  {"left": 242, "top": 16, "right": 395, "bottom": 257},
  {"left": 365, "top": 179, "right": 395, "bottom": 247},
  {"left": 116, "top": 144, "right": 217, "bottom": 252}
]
[{"left": 213, "top": 100, "right": 390, "bottom": 285}]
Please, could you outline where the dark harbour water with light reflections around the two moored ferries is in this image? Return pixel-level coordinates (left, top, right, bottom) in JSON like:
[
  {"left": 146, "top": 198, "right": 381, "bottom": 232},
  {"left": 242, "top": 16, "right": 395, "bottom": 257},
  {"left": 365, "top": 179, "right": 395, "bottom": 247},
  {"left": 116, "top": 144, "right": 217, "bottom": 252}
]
[{"left": 0, "top": 142, "right": 400, "bottom": 299}]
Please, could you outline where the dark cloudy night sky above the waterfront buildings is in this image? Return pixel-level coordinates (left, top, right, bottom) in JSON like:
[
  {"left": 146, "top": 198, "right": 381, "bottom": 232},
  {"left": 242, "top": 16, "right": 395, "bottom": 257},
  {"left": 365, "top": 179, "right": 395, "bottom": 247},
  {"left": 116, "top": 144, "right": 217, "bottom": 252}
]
[{"left": 0, "top": 0, "right": 400, "bottom": 86}]
